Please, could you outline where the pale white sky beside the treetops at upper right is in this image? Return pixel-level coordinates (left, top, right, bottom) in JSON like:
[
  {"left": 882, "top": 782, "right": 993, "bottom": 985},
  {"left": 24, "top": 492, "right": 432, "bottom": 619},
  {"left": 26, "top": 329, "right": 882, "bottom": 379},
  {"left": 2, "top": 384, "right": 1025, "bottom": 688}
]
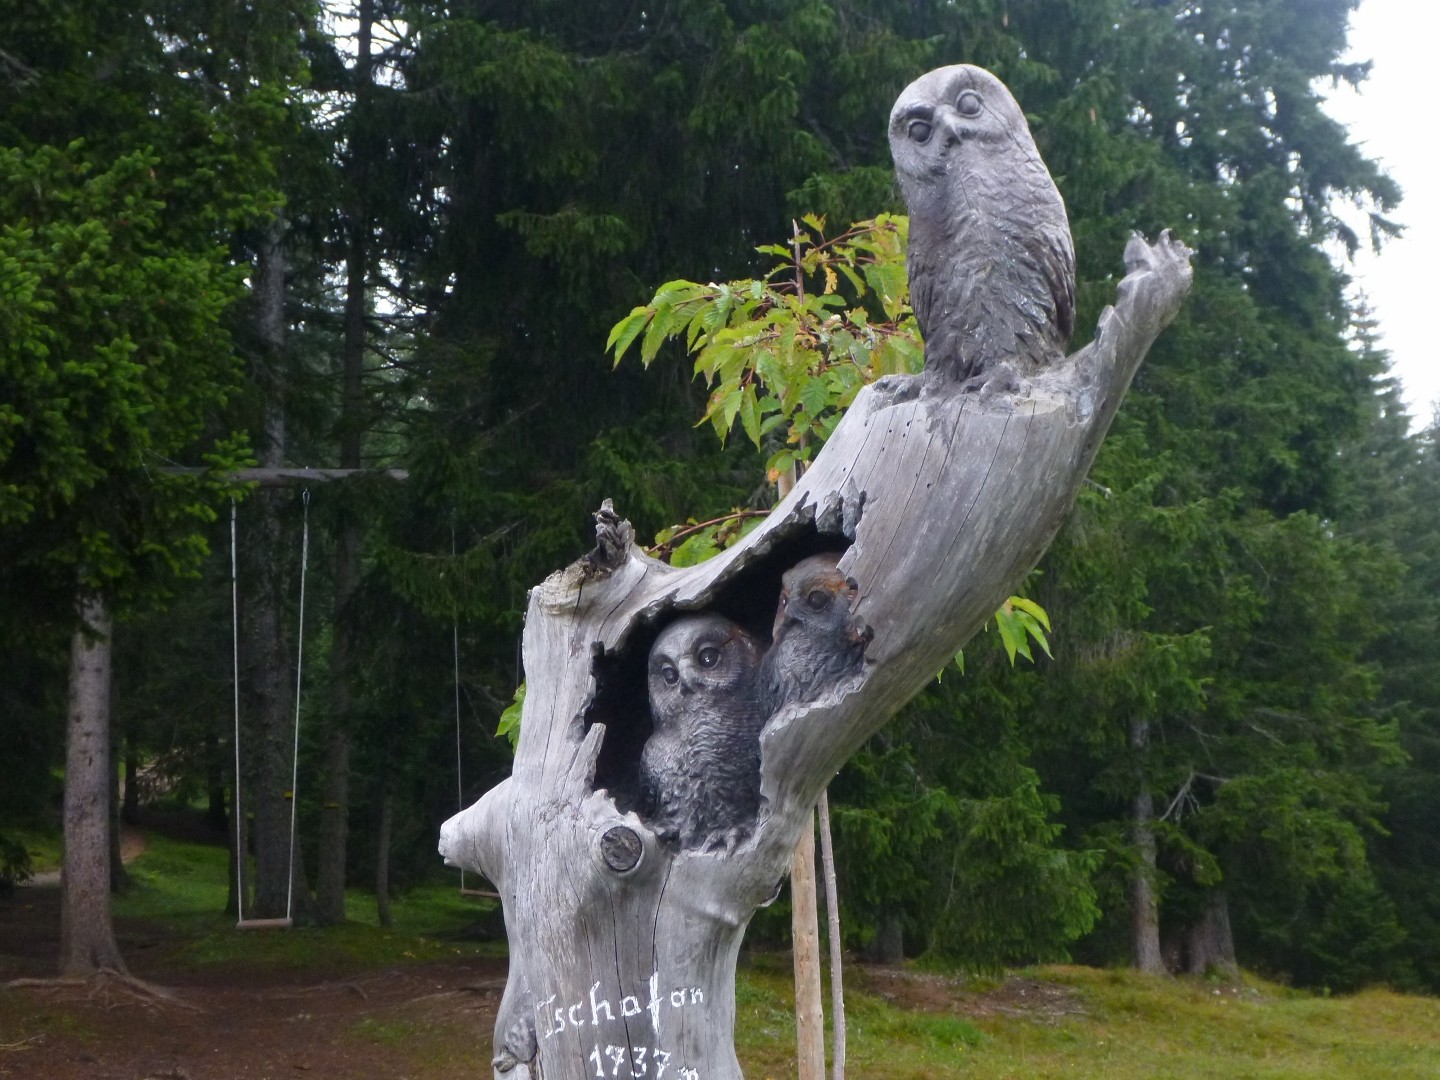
[{"left": 1322, "top": 0, "right": 1440, "bottom": 428}]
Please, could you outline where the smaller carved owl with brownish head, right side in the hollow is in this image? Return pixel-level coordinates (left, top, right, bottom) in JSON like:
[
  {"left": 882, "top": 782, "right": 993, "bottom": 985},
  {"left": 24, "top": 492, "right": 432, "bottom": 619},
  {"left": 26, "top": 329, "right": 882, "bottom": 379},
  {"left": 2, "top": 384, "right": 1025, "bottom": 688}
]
[{"left": 760, "top": 552, "right": 873, "bottom": 716}]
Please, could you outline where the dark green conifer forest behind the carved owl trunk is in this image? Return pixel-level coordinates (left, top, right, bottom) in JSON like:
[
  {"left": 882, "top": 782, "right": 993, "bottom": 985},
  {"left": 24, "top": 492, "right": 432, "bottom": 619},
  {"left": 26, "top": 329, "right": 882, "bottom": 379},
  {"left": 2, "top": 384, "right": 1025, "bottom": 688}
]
[{"left": 0, "top": 0, "right": 1440, "bottom": 991}]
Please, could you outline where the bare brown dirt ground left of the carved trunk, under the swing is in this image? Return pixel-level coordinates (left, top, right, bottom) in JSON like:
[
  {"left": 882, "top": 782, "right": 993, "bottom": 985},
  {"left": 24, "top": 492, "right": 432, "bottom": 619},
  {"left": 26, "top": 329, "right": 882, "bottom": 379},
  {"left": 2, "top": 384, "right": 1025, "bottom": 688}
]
[{"left": 0, "top": 886, "right": 505, "bottom": 1080}]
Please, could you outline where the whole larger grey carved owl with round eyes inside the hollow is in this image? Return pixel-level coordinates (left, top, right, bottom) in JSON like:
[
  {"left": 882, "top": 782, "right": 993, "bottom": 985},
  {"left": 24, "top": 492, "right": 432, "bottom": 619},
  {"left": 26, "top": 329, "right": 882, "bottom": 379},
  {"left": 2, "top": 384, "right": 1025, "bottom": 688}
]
[{"left": 639, "top": 613, "right": 766, "bottom": 850}]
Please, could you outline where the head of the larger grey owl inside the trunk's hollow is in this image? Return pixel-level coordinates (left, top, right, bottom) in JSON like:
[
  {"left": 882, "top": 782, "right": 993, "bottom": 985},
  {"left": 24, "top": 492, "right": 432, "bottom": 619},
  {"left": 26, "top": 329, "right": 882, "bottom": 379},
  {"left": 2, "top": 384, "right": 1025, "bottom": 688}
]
[{"left": 649, "top": 612, "right": 760, "bottom": 730}]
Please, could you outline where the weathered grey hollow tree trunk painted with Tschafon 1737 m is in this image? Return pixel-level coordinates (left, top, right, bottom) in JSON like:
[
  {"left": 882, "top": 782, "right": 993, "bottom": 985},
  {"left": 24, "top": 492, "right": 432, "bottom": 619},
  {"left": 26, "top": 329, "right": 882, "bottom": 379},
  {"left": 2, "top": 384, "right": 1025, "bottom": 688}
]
[{"left": 441, "top": 224, "right": 1189, "bottom": 1080}]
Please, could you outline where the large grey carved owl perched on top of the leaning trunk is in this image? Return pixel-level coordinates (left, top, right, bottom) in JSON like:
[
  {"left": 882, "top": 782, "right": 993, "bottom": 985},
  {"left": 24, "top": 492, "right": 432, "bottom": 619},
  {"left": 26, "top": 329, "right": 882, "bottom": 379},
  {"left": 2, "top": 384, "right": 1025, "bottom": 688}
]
[{"left": 890, "top": 65, "right": 1076, "bottom": 383}]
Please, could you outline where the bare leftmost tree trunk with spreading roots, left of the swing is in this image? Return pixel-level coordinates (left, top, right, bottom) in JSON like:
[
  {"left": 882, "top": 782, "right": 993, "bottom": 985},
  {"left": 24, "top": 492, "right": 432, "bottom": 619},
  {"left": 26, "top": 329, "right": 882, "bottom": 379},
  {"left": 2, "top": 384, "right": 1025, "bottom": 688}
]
[{"left": 60, "top": 596, "right": 125, "bottom": 975}]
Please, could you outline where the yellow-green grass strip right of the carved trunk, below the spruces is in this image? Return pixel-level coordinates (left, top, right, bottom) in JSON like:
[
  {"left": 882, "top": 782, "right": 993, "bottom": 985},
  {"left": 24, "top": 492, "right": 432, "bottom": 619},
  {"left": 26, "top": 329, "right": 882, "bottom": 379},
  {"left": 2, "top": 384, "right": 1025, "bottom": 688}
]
[{"left": 739, "top": 966, "right": 1440, "bottom": 1080}]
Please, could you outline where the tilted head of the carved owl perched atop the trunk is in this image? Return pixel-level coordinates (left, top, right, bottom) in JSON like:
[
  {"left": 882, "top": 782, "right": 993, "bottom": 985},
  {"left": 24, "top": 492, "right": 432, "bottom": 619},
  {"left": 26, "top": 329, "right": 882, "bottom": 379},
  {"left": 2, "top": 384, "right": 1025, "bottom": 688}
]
[{"left": 890, "top": 63, "right": 1044, "bottom": 205}]
